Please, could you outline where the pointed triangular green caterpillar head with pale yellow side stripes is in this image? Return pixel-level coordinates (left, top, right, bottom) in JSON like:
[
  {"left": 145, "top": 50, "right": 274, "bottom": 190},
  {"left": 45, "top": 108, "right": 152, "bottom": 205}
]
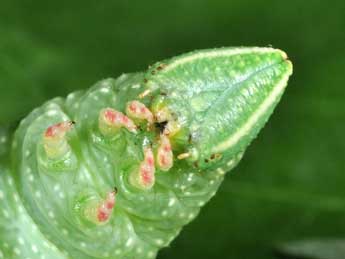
[{"left": 144, "top": 48, "right": 292, "bottom": 171}]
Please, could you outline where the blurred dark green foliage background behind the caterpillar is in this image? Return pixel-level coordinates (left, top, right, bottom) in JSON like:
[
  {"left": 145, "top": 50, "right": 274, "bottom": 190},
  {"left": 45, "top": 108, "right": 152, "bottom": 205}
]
[{"left": 0, "top": 0, "right": 345, "bottom": 259}]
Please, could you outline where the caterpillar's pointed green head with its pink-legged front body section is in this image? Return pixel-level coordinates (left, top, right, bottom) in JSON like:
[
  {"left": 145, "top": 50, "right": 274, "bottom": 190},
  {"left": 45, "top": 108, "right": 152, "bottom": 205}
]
[{"left": 13, "top": 48, "right": 292, "bottom": 258}]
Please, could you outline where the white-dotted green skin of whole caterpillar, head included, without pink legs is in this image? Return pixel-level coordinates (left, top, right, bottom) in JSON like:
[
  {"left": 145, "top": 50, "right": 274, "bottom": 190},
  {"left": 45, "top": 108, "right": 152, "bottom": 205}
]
[{"left": 0, "top": 48, "right": 292, "bottom": 258}]
